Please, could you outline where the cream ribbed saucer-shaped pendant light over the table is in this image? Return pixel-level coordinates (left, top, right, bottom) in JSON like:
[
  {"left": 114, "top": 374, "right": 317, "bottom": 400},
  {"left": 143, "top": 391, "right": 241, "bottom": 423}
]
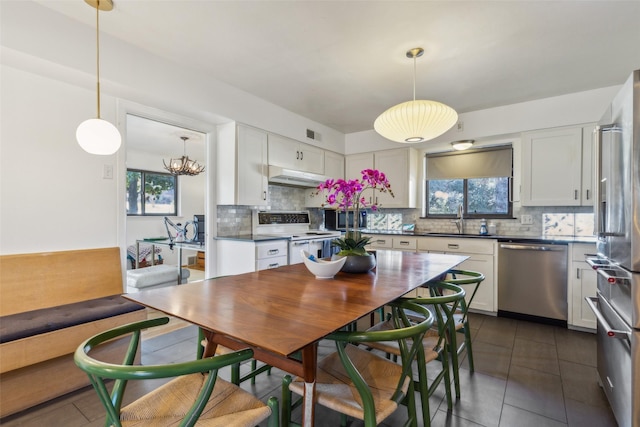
[{"left": 373, "top": 47, "right": 458, "bottom": 143}]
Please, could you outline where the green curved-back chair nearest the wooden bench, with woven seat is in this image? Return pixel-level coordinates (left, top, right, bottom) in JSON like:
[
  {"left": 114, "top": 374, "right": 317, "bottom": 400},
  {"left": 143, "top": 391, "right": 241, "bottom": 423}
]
[{"left": 74, "top": 317, "right": 279, "bottom": 427}]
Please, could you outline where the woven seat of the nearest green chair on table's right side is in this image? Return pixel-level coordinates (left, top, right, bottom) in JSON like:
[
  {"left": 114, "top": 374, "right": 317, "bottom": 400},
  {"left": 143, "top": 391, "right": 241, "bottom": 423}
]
[{"left": 289, "top": 345, "right": 409, "bottom": 423}]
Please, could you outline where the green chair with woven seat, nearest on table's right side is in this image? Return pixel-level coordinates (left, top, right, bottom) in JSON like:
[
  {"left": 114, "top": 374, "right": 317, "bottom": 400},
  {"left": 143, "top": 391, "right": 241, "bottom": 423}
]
[{"left": 282, "top": 301, "right": 433, "bottom": 427}]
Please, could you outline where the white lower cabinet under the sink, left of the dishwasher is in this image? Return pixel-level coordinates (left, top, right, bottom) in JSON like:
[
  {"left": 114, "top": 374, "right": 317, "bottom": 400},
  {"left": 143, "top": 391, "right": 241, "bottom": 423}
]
[{"left": 418, "top": 237, "right": 498, "bottom": 313}]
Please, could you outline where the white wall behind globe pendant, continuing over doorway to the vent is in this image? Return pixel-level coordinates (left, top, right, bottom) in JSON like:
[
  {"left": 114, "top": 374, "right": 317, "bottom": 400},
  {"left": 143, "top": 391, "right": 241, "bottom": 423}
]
[{"left": 0, "top": 0, "right": 344, "bottom": 254}]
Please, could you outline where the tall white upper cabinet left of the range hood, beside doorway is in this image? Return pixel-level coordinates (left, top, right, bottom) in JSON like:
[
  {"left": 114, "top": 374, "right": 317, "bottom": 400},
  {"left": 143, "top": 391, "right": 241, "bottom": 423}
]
[{"left": 216, "top": 124, "right": 269, "bottom": 206}]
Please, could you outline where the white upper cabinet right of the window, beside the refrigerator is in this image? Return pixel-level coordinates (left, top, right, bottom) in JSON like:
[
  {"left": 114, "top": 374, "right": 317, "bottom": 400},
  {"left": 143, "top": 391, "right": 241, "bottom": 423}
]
[{"left": 521, "top": 127, "right": 593, "bottom": 206}]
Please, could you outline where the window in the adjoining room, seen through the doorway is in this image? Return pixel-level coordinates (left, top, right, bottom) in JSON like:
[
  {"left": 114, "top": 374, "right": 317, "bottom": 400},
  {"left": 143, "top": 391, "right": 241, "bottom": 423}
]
[{"left": 127, "top": 169, "right": 178, "bottom": 216}]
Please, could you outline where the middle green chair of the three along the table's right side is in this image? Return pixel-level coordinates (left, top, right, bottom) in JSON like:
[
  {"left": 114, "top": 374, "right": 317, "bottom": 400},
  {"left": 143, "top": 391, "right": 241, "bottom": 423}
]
[{"left": 366, "top": 282, "right": 465, "bottom": 426}]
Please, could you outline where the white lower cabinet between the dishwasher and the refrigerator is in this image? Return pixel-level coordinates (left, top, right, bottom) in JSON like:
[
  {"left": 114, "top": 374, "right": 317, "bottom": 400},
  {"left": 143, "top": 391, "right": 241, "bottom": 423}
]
[{"left": 567, "top": 243, "right": 598, "bottom": 330}]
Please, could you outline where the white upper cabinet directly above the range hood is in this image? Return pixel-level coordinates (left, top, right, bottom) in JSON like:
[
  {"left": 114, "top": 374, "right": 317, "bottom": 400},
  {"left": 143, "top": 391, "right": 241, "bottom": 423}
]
[{"left": 269, "top": 134, "right": 324, "bottom": 174}]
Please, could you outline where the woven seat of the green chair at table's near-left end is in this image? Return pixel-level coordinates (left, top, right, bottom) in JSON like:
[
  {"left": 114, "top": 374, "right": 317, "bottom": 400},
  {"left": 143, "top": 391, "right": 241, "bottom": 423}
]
[{"left": 120, "top": 373, "right": 271, "bottom": 427}]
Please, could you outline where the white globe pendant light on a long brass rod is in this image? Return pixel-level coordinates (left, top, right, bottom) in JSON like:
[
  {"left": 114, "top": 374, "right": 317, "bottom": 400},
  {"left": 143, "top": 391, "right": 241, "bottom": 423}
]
[{"left": 76, "top": 0, "right": 122, "bottom": 155}]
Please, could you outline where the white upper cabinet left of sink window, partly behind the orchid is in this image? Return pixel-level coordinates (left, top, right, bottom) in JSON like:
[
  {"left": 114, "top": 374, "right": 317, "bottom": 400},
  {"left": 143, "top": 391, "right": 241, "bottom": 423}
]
[{"left": 345, "top": 148, "right": 418, "bottom": 209}]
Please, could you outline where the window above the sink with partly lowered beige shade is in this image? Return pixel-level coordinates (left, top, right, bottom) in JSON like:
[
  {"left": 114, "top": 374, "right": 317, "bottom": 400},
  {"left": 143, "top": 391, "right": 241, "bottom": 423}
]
[{"left": 425, "top": 146, "right": 513, "bottom": 218}]
